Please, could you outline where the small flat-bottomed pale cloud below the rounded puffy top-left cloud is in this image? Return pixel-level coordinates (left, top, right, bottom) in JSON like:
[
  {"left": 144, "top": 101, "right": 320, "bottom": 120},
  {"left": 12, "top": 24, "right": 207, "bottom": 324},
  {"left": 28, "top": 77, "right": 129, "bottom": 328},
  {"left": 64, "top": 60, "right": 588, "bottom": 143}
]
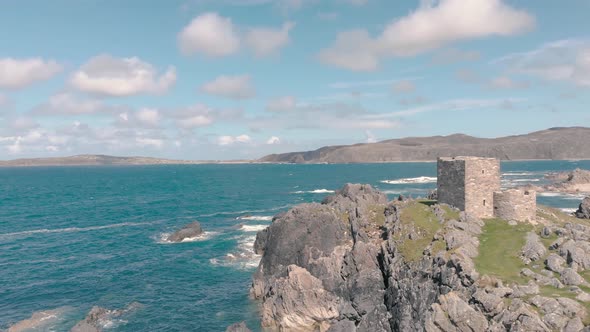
[{"left": 200, "top": 75, "right": 256, "bottom": 100}]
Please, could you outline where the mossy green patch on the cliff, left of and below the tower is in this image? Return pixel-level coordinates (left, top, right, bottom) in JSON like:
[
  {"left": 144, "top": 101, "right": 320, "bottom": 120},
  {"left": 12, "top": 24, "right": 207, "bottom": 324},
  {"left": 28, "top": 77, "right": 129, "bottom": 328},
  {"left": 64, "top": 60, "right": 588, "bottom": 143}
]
[{"left": 394, "top": 202, "right": 441, "bottom": 262}]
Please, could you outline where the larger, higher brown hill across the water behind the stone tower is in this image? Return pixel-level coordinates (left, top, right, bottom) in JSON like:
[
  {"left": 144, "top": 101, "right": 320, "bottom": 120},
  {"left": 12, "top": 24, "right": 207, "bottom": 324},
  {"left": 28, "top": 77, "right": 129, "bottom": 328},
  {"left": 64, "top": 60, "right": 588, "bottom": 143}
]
[{"left": 258, "top": 127, "right": 590, "bottom": 163}]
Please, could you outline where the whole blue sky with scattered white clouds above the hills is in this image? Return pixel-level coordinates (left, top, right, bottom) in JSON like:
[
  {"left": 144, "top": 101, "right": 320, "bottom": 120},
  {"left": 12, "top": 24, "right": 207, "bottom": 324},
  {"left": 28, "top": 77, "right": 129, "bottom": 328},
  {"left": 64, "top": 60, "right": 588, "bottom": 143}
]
[{"left": 0, "top": 0, "right": 590, "bottom": 160}]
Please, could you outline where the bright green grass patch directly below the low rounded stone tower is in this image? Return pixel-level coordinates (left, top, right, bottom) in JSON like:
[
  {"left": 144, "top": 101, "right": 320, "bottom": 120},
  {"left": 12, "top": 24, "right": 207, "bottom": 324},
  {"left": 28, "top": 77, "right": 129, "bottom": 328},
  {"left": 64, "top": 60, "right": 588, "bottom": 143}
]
[{"left": 475, "top": 219, "right": 533, "bottom": 283}]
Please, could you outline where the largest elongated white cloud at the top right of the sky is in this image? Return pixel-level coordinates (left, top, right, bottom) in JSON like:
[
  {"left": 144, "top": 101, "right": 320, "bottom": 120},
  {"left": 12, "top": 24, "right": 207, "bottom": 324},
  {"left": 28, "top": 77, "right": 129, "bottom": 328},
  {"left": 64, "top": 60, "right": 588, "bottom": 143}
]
[{"left": 319, "top": 0, "right": 535, "bottom": 71}]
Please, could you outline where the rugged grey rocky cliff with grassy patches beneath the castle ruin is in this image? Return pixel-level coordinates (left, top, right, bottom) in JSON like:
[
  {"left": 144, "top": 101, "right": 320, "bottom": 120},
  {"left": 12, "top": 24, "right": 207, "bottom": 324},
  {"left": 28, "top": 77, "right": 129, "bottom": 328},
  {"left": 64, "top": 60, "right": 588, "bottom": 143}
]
[{"left": 251, "top": 185, "right": 590, "bottom": 331}]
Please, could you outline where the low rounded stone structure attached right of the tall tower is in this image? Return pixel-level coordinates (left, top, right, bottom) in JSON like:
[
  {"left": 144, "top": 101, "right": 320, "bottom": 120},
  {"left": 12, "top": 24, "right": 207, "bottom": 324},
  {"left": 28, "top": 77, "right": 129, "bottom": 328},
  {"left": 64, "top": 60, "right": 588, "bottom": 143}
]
[{"left": 494, "top": 189, "right": 537, "bottom": 221}]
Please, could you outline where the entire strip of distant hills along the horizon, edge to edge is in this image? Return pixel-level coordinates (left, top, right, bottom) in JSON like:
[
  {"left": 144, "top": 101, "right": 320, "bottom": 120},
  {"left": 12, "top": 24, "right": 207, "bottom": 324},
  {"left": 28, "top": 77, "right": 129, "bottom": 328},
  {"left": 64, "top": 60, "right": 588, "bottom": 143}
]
[{"left": 0, "top": 127, "right": 590, "bottom": 167}]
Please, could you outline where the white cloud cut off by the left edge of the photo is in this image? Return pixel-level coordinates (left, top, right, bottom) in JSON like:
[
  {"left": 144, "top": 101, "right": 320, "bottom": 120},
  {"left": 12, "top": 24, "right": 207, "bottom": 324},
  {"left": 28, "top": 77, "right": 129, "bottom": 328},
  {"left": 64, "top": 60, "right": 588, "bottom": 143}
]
[{"left": 0, "top": 58, "right": 62, "bottom": 89}]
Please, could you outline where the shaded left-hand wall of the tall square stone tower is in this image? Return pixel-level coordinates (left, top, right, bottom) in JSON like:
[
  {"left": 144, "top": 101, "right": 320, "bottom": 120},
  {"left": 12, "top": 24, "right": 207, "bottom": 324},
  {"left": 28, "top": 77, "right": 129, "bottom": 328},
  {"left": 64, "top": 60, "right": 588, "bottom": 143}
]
[{"left": 437, "top": 158, "right": 465, "bottom": 211}]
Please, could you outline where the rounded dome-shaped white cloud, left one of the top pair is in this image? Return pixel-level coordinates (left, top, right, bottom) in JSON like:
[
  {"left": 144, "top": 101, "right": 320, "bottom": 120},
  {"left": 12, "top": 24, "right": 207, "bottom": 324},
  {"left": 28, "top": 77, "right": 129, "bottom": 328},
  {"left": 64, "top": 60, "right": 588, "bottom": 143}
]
[{"left": 178, "top": 13, "right": 240, "bottom": 57}]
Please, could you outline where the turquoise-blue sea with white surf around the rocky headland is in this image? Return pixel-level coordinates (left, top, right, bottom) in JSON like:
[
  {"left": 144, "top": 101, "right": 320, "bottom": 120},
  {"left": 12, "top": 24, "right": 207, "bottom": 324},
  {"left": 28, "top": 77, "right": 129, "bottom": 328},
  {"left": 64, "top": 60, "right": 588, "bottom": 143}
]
[{"left": 0, "top": 161, "right": 590, "bottom": 331}]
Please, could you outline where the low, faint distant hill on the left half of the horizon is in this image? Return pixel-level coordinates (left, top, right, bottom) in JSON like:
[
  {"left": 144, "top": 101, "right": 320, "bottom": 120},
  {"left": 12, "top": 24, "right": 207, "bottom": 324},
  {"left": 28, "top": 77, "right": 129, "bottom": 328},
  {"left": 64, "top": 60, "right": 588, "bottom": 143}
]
[{"left": 0, "top": 155, "right": 207, "bottom": 167}]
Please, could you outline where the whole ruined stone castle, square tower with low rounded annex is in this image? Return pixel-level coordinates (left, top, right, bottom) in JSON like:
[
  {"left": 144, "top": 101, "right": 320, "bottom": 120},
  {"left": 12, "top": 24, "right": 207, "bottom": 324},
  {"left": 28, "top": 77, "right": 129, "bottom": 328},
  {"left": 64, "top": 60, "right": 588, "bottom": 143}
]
[{"left": 437, "top": 157, "right": 537, "bottom": 221}]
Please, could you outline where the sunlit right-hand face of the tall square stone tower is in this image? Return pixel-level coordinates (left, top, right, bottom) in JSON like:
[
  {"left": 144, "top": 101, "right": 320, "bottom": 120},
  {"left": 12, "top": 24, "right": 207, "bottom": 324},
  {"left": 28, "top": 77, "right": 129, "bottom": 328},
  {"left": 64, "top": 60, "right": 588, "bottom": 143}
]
[{"left": 465, "top": 157, "right": 500, "bottom": 218}]
